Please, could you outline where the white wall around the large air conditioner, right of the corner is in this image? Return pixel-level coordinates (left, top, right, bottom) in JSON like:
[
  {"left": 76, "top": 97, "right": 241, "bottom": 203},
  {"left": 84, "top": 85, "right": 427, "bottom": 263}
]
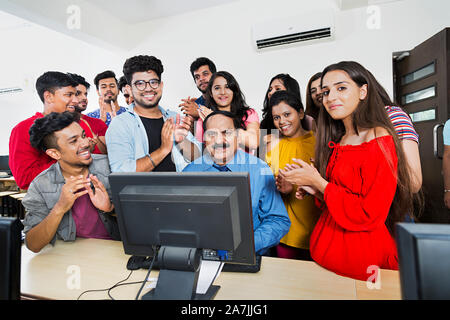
[{"left": 129, "top": 0, "right": 450, "bottom": 116}]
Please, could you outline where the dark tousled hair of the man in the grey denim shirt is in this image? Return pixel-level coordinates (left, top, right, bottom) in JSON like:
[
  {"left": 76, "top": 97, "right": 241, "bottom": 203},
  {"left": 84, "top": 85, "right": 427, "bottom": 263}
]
[{"left": 29, "top": 111, "right": 77, "bottom": 152}]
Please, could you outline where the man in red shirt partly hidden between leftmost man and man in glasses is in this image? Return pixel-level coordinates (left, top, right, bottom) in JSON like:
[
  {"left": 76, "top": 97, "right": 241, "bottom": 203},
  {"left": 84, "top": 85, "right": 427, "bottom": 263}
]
[{"left": 70, "top": 73, "right": 108, "bottom": 154}]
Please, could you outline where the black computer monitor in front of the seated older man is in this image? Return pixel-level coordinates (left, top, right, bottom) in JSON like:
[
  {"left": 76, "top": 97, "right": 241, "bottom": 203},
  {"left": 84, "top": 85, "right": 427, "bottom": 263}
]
[{"left": 109, "top": 172, "right": 256, "bottom": 299}]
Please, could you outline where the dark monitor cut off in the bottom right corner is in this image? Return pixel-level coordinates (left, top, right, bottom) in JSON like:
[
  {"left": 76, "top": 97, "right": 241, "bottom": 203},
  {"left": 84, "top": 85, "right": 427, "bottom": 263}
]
[{"left": 396, "top": 223, "right": 450, "bottom": 300}]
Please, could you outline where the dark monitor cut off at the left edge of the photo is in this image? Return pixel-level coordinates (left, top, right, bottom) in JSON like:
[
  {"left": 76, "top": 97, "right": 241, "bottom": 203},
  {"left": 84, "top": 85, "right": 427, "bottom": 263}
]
[{"left": 0, "top": 217, "right": 23, "bottom": 300}]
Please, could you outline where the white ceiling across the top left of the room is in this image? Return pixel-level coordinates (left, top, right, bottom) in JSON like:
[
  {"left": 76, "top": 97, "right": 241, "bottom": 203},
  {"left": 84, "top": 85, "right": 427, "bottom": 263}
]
[{"left": 0, "top": 0, "right": 239, "bottom": 50}]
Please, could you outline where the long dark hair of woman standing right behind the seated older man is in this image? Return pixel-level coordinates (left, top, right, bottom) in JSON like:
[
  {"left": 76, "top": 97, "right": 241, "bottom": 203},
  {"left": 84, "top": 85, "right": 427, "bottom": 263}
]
[{"left": 205, "top": 71, "right": 250, "bottom": 129}]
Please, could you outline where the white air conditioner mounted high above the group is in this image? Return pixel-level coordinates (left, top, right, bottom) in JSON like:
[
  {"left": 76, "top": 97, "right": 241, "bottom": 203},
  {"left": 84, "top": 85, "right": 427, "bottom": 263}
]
[{"left": 252, "top": 11, "right": 334, "bottom": 49}]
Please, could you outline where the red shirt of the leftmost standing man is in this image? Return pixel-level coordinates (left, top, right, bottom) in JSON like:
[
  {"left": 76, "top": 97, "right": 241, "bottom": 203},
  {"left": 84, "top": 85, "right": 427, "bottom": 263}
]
[{"left": 9, "top": 112, "right": 56, "bottom": 189}]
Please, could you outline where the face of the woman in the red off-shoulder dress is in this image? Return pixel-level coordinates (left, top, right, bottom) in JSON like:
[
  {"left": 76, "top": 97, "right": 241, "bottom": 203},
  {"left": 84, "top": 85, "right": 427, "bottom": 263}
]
[{"left": 322, "top": 70, "right": 367, "bottom": 120}]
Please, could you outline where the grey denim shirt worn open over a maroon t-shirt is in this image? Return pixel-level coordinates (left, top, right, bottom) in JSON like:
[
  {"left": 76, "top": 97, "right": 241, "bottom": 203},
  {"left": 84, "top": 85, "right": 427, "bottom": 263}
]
[{"left": 22, "top": 154, "right": 120, "bottom": 244}]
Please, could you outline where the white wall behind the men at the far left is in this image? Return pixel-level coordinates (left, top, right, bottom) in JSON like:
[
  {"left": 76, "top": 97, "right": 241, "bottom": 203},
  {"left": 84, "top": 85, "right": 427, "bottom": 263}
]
[{"left": 0, "top": 11, "right": 122, "bottom": 154}]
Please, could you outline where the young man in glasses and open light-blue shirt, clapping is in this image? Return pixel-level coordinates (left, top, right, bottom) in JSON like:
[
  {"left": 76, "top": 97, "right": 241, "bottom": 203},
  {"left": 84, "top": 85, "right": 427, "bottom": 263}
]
[{"left": 106, "top": 56, "right": 200, "bottom": 172}]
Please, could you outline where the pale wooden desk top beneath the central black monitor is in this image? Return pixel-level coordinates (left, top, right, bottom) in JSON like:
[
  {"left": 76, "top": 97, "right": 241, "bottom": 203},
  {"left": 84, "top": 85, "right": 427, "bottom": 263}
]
[{"left": 21, "top": 239, "right": 401, "bottom": 300}]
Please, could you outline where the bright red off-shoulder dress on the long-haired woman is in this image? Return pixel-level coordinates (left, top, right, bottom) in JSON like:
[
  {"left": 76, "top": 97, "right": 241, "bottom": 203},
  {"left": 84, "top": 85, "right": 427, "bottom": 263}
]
[{"left": 310, "top": 136, "right": 398, "bottom": 281}]
